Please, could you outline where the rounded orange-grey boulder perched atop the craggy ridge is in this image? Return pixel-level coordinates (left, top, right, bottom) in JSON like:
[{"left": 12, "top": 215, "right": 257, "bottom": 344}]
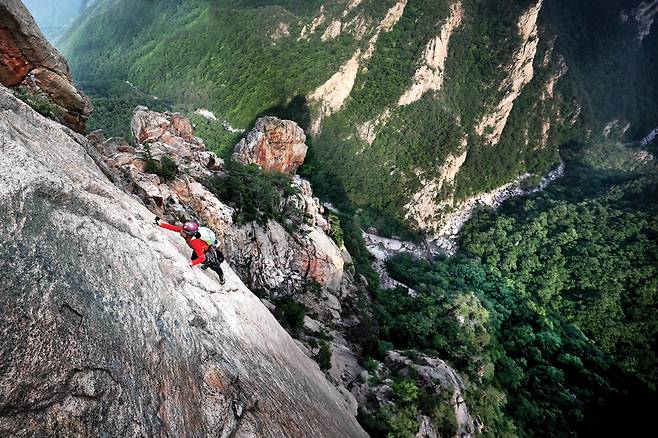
[{"left": 233, "top": 117, "right": 308, "bottom": 174}]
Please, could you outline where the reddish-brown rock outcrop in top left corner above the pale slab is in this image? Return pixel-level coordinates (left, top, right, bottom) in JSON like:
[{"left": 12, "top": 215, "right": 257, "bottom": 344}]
[{"left": 0, "top": 0, "right": 91, "bottom": 132}]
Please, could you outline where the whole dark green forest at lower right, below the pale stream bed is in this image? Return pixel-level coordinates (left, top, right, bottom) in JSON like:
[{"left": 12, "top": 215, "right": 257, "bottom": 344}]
[{"left": 348, "top": 144, "right": 658, "bottom": 437}]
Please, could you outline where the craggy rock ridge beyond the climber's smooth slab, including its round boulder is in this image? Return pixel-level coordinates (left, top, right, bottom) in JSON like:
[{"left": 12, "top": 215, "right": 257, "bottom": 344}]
[{"left": 88, "top": 106, "right": 380, "bottom": 426}]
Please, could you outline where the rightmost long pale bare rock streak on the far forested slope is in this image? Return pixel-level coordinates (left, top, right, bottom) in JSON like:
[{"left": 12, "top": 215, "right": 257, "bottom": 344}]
[{"left": 476, "top": 0, "right": 543, "bottom": 144}]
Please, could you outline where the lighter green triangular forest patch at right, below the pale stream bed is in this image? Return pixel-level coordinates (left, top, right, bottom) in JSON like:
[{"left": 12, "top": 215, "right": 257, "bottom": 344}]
[{"left": 462, "top": 149, "right": 658, "bottom": 388}]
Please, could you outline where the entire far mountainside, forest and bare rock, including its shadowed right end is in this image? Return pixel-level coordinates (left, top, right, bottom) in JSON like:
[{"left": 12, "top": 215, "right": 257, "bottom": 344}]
[{"left": 63, "top": 0, "right": 658, "bottom": 238}]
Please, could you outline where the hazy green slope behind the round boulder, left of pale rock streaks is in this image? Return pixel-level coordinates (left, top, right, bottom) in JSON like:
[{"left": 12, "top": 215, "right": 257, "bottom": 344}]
[{"left": 63, "top": 0, "right": 356, "bottom": 123}]
